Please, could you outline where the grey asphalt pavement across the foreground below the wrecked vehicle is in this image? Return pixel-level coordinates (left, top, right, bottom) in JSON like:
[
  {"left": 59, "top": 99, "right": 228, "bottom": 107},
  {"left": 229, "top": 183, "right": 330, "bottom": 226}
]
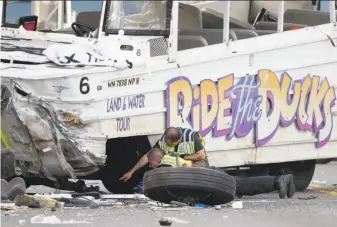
[{"left": 1, "top": 162, "right": 337, "bottom": 227}]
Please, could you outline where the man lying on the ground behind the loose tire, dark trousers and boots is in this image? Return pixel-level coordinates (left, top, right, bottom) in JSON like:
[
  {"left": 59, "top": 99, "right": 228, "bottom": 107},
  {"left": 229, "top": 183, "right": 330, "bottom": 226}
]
[{"left": 147, "top": 148, "right": 296, "bottom": 198}]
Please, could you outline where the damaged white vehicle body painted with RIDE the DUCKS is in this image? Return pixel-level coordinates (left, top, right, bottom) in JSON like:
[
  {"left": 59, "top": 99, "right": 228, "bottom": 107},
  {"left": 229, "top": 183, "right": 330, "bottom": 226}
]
[{"left": 1, "top": 0, "right": 337, "bottom": 179}]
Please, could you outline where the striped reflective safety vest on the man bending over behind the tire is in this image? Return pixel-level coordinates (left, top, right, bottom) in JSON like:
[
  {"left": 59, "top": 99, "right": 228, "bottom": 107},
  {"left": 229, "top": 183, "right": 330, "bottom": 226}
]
[{"left": 159, "top": 129, "right": 205, "bottom": 155}]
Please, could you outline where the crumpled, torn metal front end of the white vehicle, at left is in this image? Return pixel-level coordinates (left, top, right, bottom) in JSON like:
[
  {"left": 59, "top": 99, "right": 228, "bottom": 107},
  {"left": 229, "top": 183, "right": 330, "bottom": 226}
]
[{"left": 1, "top": 82, "right": 106, "bottom": 179}]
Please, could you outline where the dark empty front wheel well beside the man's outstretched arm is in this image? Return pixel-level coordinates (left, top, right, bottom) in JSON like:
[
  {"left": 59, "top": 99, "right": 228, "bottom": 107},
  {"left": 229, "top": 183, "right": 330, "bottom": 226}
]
[{"left": 102, "top": 136, "right": 151, "bottom": 193}]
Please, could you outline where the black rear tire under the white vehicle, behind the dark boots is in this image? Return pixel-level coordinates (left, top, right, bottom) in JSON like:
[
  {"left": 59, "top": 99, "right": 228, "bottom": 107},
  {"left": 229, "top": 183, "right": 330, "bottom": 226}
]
[{"left": 284, "top": 160, "right": 316, "bottom": 191}]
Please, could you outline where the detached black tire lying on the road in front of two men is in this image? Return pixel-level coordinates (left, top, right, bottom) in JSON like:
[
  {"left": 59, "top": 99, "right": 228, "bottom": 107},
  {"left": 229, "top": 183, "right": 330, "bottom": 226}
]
[{"left": 143, "top": 167, "right": 236, "bottom": 205}]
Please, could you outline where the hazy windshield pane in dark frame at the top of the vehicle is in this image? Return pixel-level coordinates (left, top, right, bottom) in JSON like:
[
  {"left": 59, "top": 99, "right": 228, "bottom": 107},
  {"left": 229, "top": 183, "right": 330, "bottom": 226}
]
[{"left": 105, "top": 0, "right": 172, "bottom": 35}]
